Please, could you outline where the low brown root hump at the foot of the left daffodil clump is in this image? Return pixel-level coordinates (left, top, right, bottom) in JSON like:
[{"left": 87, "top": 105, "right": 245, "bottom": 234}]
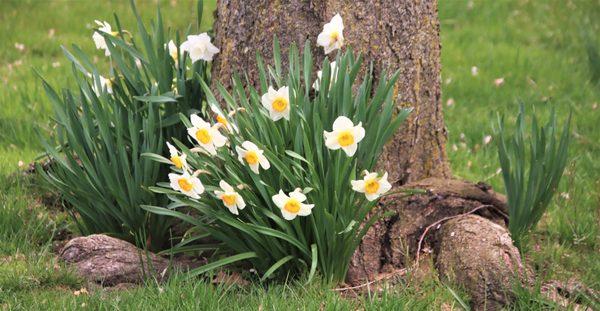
[{"left": 60, "top": 234, "right": 203, "bottom": 286}]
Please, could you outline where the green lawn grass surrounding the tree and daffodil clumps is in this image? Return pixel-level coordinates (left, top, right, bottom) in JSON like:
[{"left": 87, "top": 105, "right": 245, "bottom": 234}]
[{"left": 0, "top": 0, "right": 600, "bottom": 310}]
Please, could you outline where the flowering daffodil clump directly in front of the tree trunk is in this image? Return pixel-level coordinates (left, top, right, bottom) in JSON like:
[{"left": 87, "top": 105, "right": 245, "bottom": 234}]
[{"left": 147, "top": 15, "right": 409, "bottom": 281}]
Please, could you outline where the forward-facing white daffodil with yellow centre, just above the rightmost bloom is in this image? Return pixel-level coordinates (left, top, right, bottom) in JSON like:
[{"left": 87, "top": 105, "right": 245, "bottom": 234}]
[{"left": 323, "top": 116, "right": 365, "bottom": 157}]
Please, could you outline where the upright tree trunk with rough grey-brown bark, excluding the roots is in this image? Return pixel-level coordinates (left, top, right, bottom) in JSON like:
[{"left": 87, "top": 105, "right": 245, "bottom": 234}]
[{"left": 212, "top": 0, "right": 450, "bottom": 185}]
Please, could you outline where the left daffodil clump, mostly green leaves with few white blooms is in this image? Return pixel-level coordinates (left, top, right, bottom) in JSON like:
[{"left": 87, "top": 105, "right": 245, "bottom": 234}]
[{"left": 38, "top": 2, "right": 218, "bottom": 249}]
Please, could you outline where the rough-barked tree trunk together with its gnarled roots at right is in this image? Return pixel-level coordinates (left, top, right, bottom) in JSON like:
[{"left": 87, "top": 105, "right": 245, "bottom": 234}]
[{"left": 212, "top": 0, "right": 520, "bottom": 307}]
